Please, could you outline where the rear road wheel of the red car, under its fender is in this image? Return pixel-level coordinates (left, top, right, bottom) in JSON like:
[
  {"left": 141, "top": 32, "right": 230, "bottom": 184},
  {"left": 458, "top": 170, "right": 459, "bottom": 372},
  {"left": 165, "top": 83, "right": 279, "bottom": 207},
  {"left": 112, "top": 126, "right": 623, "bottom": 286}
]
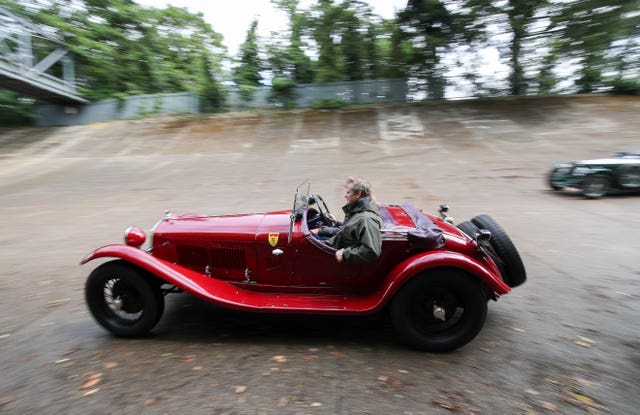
[{"left": 391, "top": 268, "right": 487, "bottom": 353}]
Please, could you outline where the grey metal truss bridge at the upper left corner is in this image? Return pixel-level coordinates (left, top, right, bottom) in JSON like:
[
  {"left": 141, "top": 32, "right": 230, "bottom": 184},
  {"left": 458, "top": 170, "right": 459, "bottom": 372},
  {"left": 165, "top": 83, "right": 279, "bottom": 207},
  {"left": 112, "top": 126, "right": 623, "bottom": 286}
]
[{"left": 0, "top": 7, "right": 89, "bottom": 105}]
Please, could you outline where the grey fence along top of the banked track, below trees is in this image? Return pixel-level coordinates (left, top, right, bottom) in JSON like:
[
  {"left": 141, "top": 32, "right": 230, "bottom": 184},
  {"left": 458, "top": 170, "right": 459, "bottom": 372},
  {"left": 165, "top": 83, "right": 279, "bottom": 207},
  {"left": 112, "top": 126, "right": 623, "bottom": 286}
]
[{"left": 34, "top": 79, "right": 407, "bottom": 126}]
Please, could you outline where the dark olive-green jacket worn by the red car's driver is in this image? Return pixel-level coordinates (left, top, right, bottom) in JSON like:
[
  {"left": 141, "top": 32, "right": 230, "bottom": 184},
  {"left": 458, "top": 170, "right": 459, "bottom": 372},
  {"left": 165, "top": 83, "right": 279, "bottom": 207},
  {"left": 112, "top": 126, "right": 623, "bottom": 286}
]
[{"left": 327, "top": 197, "right": 382, "bottom": 263}]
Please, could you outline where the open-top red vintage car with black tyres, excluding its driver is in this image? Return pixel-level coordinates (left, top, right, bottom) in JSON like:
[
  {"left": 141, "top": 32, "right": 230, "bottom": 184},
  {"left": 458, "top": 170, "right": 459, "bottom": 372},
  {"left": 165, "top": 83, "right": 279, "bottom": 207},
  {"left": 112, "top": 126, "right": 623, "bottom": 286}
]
[{"left": 81, "top": 185, "right": 526, "bottom": 352}]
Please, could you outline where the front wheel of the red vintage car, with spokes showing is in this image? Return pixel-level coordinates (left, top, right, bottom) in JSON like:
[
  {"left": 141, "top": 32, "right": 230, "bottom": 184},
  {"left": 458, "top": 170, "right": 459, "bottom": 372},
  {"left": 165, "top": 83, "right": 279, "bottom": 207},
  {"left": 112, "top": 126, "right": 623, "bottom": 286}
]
[{"left": 85, "top": 260, "right": 164, "bottom": 337}]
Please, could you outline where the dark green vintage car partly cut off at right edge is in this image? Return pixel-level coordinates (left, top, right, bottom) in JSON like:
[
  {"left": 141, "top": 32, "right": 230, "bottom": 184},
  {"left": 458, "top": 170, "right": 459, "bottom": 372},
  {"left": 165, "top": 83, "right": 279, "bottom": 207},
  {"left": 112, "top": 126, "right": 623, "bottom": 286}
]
[{"left": 549, "top": 152, "right": 640, "bottom": 199}]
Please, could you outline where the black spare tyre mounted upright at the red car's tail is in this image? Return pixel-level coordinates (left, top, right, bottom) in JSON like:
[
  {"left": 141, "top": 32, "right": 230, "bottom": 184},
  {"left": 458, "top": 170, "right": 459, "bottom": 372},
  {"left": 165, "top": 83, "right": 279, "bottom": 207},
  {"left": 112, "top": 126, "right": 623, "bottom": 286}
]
[{"left": 471, "top": 215, "right": 527, "bottom": 288}]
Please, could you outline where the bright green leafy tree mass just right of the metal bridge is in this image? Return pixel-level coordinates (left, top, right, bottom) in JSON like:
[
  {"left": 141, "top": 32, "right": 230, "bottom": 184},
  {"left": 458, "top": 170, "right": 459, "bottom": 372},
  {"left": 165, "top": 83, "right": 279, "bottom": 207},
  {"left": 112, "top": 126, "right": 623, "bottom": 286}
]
[{"left": 8, "top": 0, "right": 225, "bottom": 100}]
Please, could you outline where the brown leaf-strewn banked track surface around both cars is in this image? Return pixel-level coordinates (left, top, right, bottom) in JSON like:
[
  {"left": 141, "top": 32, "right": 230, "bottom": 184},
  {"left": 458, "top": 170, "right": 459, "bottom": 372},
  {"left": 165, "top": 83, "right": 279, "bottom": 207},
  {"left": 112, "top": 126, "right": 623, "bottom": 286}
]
[{"left": 0, "top": 96, "right": 640, "bottom": 415}]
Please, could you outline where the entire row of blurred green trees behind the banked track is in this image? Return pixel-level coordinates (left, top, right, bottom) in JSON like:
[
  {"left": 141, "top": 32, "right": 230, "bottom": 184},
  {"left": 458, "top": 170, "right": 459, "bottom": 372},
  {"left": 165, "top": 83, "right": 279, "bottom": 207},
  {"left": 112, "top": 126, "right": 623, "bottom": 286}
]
[{"left": 2, "top": 0, "right": 640, "bottom": 107}]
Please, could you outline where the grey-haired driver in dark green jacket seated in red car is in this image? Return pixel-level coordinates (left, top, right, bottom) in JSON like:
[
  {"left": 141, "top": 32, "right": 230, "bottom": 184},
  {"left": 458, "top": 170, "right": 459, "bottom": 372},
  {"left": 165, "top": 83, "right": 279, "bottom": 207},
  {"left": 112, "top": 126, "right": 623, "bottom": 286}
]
[{"left": 314, "top": 177, "right": 382, "bottom": 263}]
